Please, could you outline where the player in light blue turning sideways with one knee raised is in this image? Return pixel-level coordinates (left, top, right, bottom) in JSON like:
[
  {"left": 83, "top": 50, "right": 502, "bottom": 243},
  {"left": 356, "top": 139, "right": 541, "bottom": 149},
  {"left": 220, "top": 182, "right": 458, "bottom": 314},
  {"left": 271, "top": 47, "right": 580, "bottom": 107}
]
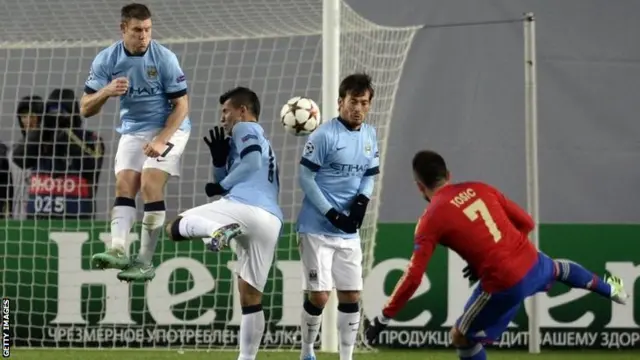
[{"left": 167, "top": 87, "right": 283, "bottom": 360}]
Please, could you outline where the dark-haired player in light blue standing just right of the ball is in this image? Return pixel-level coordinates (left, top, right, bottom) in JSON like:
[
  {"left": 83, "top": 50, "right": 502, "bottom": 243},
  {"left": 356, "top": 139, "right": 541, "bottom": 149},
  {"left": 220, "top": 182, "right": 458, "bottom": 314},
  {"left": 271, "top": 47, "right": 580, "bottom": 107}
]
[{"left": 297, "top": 74, "right": 379, "bottom": 360}]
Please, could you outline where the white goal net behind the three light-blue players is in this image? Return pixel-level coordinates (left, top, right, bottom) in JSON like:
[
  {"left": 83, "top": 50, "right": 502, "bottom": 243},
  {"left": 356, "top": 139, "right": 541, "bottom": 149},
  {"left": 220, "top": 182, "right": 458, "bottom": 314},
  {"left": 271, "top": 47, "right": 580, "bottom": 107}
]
[{"left": 0, "top": 0, "right": 417, "bottom": 349}]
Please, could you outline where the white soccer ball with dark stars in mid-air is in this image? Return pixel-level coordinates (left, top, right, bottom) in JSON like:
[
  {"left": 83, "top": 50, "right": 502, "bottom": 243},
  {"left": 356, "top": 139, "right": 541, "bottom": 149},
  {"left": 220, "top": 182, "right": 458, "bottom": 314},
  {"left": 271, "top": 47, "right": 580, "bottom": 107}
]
[{"left": 280, "top": 96, "right": 321, "bottom": 136}]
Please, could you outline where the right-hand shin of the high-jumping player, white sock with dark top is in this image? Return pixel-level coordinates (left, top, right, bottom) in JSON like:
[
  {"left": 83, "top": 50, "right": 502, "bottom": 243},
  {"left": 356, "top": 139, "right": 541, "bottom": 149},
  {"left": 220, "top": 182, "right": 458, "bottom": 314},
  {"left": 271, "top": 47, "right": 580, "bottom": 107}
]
[{"left": 138, "top": 201, "right": 166, "bottom": 265}]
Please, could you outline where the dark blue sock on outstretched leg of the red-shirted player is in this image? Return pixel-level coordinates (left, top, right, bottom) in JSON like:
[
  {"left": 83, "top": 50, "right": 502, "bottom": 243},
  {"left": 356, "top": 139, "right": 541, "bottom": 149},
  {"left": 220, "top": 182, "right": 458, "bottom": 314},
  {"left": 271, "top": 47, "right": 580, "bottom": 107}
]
[{"left": 555, "top": 260, "right": 611, "bottom": 299}]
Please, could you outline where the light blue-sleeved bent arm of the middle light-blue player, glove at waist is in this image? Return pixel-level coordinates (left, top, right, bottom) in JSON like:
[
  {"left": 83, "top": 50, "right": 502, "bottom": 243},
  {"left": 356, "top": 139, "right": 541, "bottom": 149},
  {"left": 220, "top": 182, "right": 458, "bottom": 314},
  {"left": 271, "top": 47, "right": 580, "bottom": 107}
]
[{"left": 205, "top": 122, "right": 263, "bottom": 197}]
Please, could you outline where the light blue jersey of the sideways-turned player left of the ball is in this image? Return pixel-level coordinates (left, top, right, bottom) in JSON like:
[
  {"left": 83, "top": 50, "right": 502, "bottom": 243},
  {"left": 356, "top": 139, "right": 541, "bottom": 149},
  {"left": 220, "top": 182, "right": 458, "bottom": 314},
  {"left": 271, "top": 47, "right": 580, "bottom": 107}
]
[{"left": 214, "top": 122, "right": 283, "bottom": 222}]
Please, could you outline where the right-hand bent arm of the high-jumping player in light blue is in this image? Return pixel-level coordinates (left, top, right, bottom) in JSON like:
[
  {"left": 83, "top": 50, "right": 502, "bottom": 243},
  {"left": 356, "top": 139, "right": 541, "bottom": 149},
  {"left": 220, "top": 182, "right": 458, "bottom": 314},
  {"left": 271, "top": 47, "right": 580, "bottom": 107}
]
[{"left": 157, "top": 50, "right": 189, "bottom": 144}]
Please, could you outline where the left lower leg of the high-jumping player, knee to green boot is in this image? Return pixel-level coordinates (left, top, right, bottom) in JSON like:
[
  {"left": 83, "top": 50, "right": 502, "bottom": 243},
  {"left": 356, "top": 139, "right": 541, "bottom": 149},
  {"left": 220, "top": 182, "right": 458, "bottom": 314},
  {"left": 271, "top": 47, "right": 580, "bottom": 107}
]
[{"left": 91, "top": 169, "right": 140, "bottom": 270}]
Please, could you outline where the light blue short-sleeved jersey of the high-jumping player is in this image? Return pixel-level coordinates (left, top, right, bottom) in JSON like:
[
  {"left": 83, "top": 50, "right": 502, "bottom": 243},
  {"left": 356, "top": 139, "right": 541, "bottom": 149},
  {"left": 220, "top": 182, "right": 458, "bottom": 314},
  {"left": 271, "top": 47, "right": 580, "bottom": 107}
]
[{"left": 84, "top": 40, "right": 191, "bottom": 134}]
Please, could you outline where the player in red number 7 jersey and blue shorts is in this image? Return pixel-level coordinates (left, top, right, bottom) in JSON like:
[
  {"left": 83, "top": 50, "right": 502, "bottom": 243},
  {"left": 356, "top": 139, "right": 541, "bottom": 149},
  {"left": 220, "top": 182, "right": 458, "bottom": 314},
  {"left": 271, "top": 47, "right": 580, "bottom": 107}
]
[{"left": 366, "top": 151, "right": 628, "bottom": 360}]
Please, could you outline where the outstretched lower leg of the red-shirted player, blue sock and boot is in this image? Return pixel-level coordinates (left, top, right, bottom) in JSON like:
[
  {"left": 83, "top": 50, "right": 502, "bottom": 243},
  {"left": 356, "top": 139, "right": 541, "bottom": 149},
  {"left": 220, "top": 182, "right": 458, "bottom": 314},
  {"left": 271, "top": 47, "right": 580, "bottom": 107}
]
[{"left": 554, "top": 259, "right": 629, "bottom": 304}]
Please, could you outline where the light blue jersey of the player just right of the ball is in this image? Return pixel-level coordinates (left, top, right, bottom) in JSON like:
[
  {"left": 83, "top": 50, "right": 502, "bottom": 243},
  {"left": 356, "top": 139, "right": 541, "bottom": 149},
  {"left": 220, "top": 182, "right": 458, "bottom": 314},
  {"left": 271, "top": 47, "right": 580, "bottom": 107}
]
[{"left": 297, "top": 118, "right": 380, "bottom": 238}]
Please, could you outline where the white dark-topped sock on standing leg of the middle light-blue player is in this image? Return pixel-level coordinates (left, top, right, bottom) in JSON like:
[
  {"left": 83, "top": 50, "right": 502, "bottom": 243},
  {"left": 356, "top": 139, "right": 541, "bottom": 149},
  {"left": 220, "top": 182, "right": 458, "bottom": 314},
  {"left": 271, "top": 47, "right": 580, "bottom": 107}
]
[{"left": 238, "top": 304, "right": 265, "bottom": 360}]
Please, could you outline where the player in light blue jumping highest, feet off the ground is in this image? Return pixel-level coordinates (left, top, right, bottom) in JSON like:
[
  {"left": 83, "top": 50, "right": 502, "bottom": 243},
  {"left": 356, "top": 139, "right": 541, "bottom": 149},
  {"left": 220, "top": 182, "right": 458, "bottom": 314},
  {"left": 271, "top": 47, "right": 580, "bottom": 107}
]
[{"left": 80, "top": 4, "right": 191, "bottom": 281}]
